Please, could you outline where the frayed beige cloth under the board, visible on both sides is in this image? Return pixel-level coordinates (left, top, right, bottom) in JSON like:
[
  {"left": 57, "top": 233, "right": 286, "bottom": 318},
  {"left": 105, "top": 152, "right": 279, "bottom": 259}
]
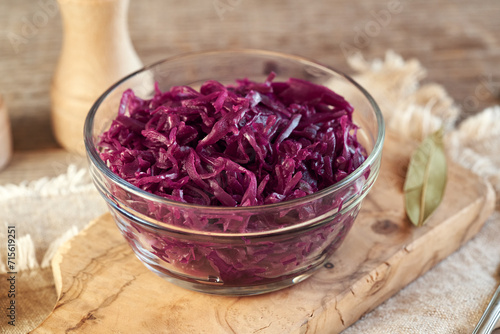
[{"left": 0, "top": 52, "right": 500, "bottom": 334}]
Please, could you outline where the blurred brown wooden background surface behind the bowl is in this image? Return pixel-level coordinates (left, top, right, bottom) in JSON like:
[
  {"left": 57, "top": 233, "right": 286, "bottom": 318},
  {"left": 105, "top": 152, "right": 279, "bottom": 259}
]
[{"left": 0, "top": 0, "right": 500, "bottom": 152}]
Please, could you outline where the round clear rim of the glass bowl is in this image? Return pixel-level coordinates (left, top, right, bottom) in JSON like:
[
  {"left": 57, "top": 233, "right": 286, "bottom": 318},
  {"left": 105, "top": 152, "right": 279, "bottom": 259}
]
[{"left": 83, "top": 49, "right": 385, "bottom": 219}]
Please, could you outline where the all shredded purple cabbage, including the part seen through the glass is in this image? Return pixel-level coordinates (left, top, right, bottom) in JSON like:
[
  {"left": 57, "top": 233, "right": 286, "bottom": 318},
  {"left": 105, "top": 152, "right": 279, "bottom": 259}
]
[{"left": 98, "top": 74, "right": 367, "bottom": 286}]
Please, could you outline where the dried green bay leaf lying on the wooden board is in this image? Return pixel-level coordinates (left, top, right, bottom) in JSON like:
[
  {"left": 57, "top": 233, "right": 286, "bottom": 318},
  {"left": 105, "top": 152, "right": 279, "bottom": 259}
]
[{"left": 404, "top": 129, "right": 447, "bottom": 226}]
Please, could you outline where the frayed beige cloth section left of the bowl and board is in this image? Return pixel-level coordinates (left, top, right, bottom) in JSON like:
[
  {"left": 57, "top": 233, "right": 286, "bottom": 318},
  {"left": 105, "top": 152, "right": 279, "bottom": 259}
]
[{"left": 0, "top": 166, "right": 106, "bottom": 333}]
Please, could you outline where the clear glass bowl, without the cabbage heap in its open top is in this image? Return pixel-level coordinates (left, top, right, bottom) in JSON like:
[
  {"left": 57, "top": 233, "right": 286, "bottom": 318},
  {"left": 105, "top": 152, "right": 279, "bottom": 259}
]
[{"left": 84, "top": 50, "right": 384, "bottom": 295}]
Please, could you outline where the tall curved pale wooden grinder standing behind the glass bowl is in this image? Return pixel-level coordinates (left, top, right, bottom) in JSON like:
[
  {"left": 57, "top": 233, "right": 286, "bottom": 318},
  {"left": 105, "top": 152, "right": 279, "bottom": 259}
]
[{"left": 51, "top": 0, "right": 142, "bottom": 154}]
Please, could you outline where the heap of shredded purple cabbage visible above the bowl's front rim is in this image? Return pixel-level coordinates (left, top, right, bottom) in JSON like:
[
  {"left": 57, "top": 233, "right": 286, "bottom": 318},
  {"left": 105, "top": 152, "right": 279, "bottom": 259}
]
[{"left": 99, "top": 74, "right": 366, "bottom": 209}]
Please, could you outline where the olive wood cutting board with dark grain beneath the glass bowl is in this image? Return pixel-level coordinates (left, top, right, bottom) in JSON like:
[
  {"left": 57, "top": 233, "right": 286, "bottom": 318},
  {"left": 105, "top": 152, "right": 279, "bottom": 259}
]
[{"left": 33, "top": 135, "right": 495, "bottom": 334}]
